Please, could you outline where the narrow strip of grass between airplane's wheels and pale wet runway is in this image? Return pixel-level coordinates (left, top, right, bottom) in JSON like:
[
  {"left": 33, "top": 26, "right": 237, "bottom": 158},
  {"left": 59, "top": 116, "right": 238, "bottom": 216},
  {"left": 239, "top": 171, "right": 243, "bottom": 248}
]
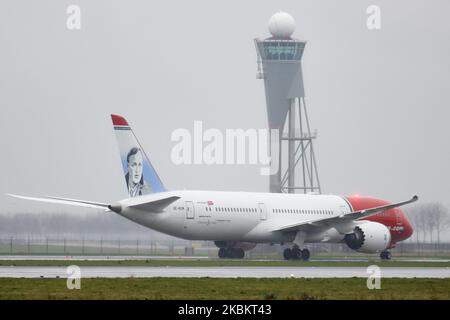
[{"left": 0, "top": 259, "right": 450, "bottom": 268}]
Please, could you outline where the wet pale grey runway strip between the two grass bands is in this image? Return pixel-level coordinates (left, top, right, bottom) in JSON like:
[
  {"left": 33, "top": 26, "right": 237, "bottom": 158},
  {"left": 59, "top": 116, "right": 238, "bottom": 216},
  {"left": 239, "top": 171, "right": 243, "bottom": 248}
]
[{"left": 0, "top": 266, "right": 450, "bottom": 278}]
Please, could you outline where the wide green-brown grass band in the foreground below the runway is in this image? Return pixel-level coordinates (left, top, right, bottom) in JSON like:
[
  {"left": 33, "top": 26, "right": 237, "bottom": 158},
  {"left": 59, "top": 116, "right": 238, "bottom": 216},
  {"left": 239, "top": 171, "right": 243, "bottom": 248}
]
[{"left": 0, "top": 278, "right": 450, "bottom": 300}]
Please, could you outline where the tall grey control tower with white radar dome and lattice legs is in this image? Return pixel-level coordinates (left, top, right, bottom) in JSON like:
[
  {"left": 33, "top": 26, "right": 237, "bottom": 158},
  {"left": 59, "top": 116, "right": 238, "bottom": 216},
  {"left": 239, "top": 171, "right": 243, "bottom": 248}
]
[{"left": 255, "top": 12, "right": 321, "bottom": 193}]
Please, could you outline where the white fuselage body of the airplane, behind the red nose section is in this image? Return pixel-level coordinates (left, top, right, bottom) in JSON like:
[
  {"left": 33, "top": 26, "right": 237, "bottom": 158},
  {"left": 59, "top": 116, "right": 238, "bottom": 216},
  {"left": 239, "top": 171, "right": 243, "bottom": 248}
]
[{"left": 115, "top": 191, "right": 351, "bottom": 243}]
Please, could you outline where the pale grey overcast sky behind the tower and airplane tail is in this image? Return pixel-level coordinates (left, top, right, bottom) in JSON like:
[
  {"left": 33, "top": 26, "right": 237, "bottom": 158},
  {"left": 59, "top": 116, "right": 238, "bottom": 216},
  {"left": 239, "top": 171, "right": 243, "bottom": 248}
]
[{"left": 0, "top": 0, "right": 450, "bottom": 232}]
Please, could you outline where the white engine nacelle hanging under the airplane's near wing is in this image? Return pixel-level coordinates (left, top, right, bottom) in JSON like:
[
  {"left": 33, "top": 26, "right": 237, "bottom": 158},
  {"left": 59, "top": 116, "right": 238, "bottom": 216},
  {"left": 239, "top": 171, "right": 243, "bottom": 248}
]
[{"left": 344, "top": 222, "right": 391, "bottom": 253}]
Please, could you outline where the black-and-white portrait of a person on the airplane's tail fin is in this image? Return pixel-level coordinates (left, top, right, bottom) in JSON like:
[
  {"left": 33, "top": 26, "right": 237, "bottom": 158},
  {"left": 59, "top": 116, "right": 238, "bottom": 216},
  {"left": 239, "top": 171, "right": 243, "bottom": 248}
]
[{"left": 125, "top": 147, "right": 152, "bottom": 197}]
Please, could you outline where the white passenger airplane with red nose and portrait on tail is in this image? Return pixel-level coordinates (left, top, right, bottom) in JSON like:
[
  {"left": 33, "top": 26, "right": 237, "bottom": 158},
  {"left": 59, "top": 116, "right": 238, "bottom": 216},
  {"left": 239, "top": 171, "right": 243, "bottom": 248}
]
[{"left": 10, "top": 114, "right": 418, "bottom": 261}]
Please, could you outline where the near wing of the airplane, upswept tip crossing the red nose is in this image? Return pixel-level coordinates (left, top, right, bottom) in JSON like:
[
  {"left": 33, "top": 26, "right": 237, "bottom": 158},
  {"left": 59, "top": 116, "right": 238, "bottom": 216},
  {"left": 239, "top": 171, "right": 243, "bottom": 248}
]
[{"left": 271, "top": 196, "right": 419, "bottom": 232}]
